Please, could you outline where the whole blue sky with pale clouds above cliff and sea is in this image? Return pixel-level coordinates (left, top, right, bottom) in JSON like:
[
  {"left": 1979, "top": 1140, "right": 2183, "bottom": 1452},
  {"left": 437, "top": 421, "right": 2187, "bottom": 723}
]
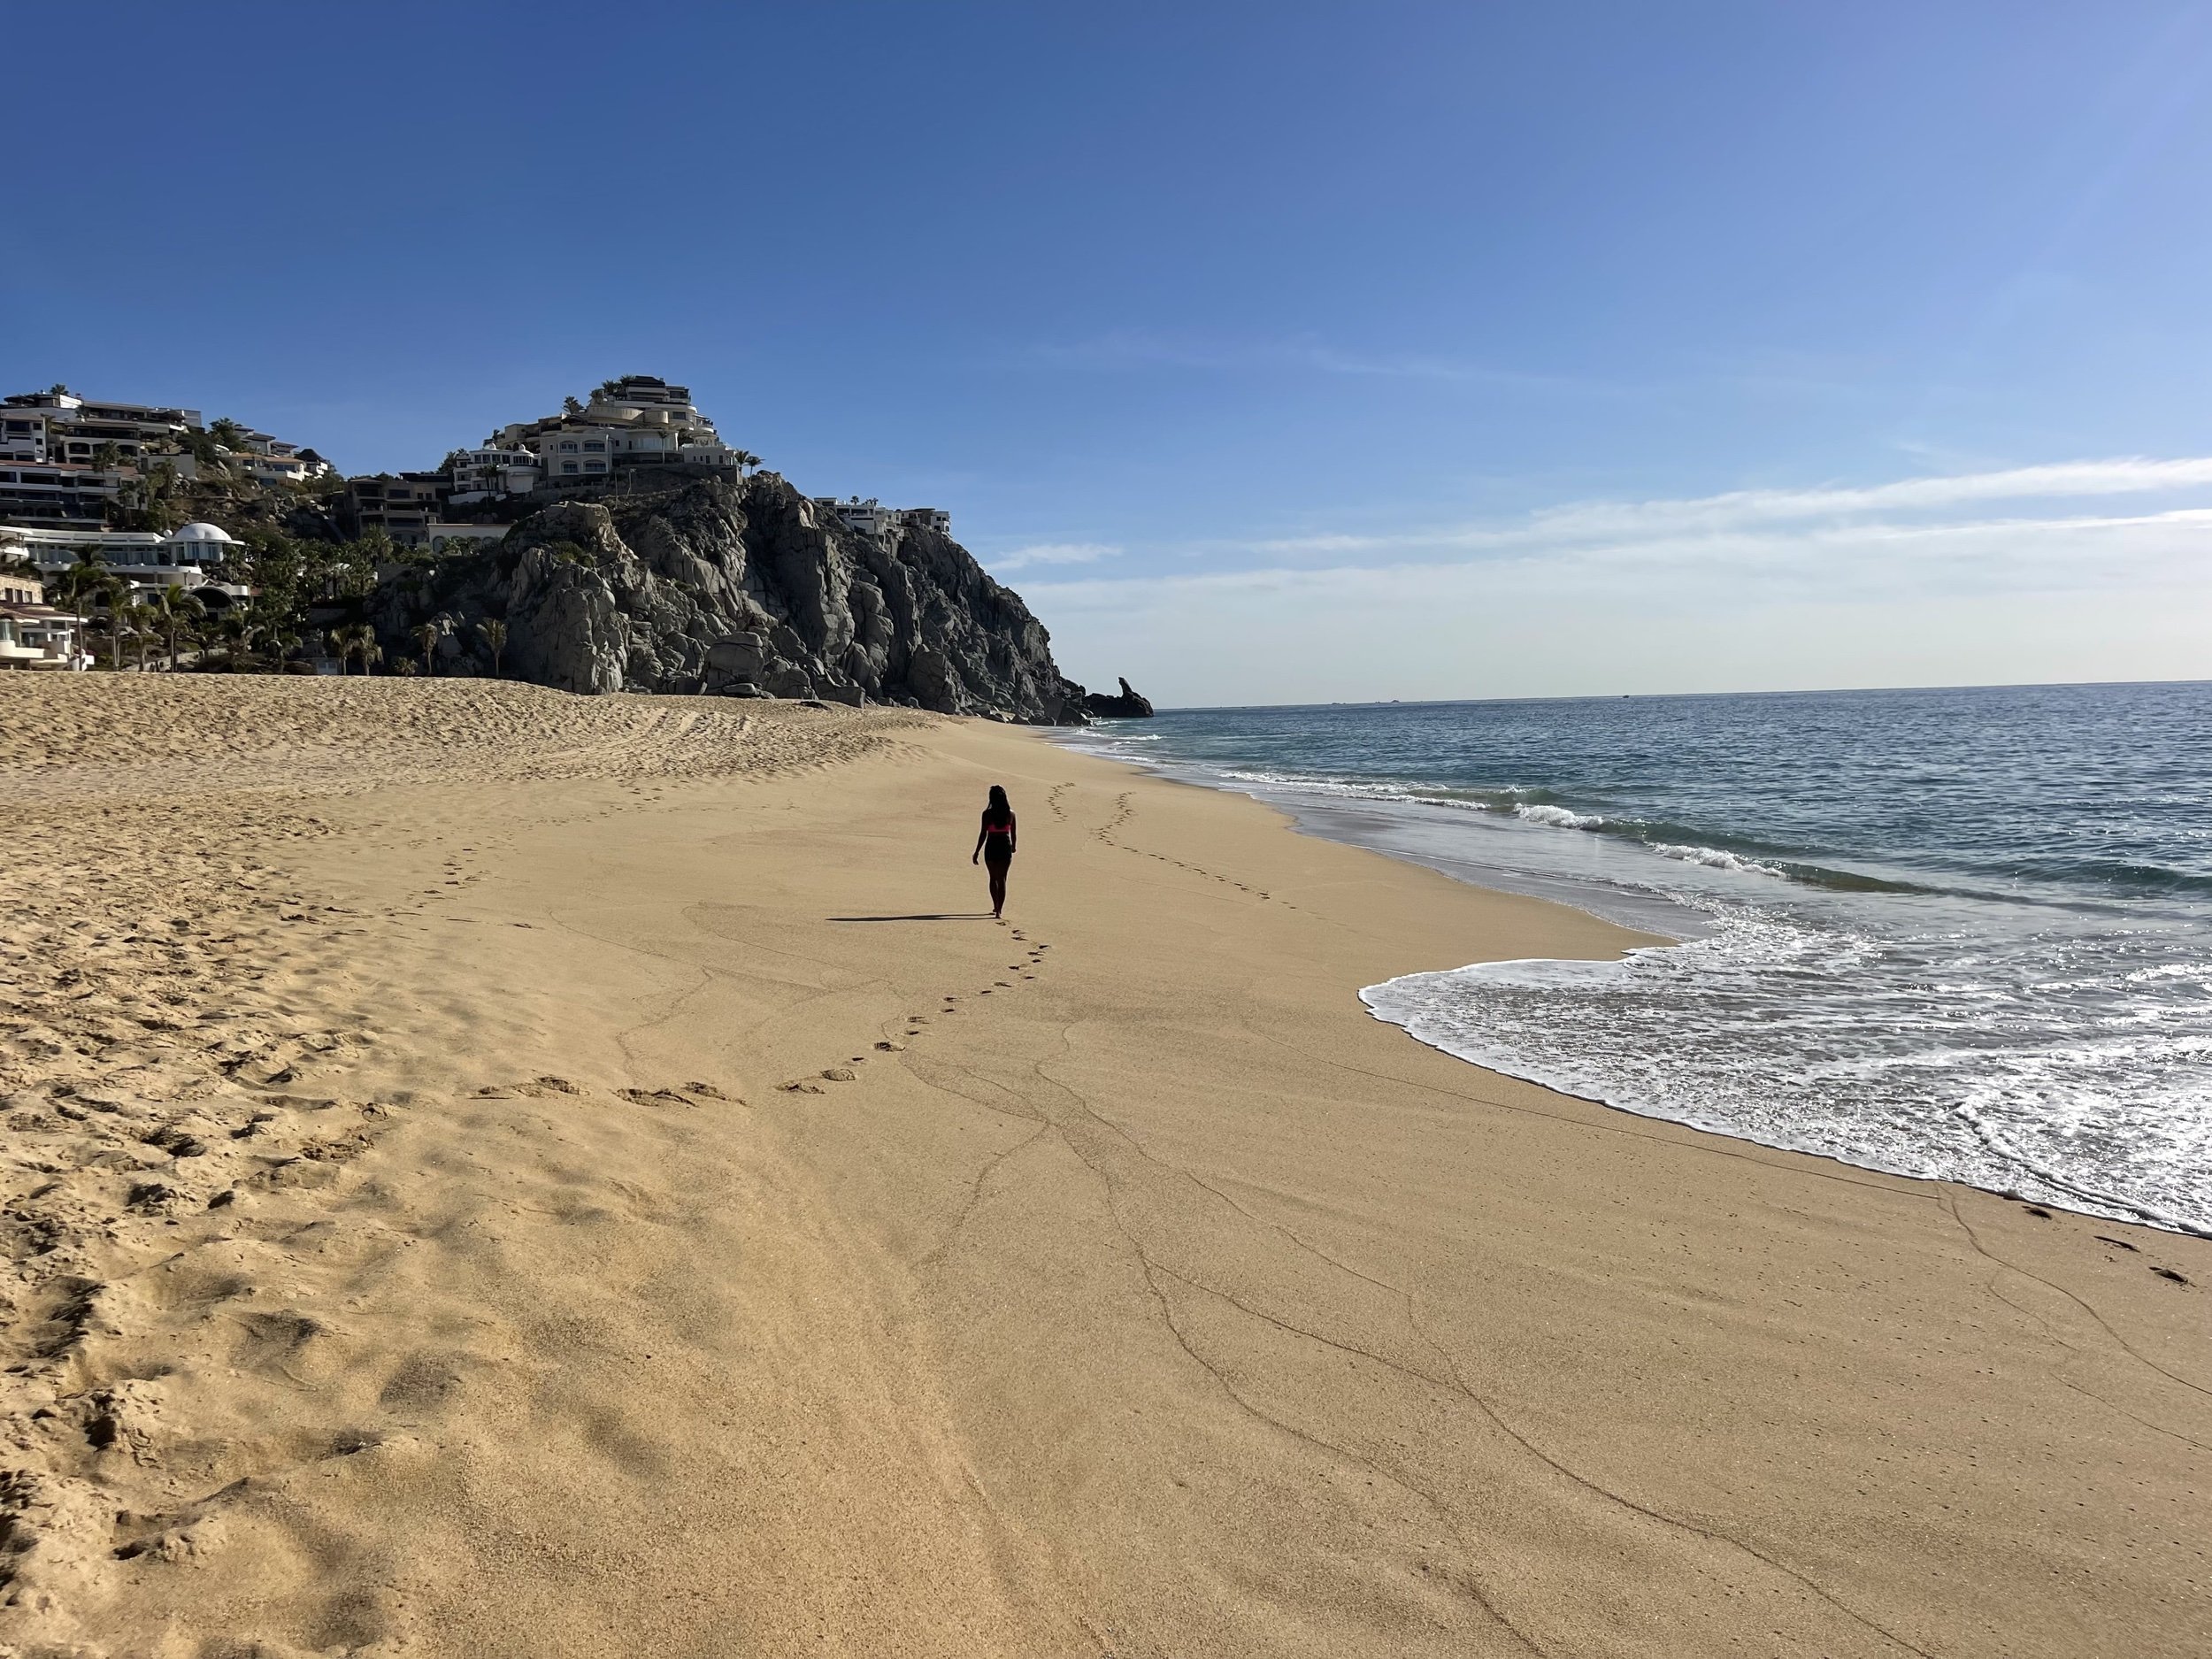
[{"left": 0, "top": 0, "right": 2212, "bottom": 702}]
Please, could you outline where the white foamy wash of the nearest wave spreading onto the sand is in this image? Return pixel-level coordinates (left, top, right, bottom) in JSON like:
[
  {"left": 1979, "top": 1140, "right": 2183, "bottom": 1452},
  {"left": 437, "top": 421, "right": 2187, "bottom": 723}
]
[{"left": 1361, "top": 907, "right": 2212, "bottom": 1234}]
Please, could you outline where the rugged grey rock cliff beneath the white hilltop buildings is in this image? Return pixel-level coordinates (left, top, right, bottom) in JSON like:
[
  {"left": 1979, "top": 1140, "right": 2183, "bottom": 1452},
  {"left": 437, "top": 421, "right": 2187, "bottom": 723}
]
[{"left": 370, "top": 473, "right": 1084, "bottom": 724}]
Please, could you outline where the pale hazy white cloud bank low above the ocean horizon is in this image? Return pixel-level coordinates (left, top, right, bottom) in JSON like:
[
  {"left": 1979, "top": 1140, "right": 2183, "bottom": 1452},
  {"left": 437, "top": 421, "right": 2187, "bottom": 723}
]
[{"left": 1025, "top": 458, "right": 2212, "bottom": 706}]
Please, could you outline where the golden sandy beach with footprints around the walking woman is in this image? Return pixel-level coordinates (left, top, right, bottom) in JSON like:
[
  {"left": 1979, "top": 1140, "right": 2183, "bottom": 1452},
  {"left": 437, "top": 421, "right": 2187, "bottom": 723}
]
[{"left": 0, "top": 675, "right": 2212, "bottom": 1659}]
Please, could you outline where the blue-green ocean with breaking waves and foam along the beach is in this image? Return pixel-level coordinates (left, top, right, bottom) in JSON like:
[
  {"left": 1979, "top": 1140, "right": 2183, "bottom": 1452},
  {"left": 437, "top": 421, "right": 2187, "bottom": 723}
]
[{"left": 1071, "top": 684, "right": 2212, "bottom": 1234}]
